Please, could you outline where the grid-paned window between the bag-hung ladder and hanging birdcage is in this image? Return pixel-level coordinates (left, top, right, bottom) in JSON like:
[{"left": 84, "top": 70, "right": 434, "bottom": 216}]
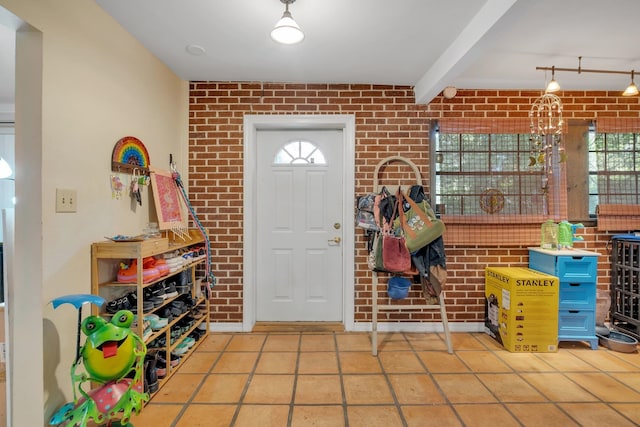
[{"left": 435, "top": 132, "right": 544, "bottom": 216}]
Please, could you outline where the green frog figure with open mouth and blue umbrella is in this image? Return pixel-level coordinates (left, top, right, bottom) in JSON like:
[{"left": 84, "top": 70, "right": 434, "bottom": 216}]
[{"left": 49, "top": 295, "right": 149, "bottom": 427}]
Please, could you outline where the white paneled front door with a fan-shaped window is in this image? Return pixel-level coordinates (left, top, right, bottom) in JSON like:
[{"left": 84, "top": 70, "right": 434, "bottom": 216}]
[{"left": 256, "top": 129, "right": 344, "bottom": 322}]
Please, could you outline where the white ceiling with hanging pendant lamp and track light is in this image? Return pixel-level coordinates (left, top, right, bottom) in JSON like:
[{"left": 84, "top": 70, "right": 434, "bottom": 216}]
[{"left": 0, "top": 0, "right": 640, "bottom": 108}]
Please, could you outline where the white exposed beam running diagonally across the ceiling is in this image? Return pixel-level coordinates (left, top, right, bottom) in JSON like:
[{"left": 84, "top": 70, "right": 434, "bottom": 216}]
[{"left": 414, "top": 0, "right": 522, "bottom": 104}]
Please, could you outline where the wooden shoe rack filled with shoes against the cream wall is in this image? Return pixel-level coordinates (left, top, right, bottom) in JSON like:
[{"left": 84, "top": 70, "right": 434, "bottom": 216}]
[{"left": 91, "top": 229, "right": 209, "bottom": 395}]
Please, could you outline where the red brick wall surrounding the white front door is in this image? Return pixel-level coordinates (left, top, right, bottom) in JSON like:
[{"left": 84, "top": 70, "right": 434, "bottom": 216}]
[{"left": 189, "top": 82, "right": 640, "bottom": 322}]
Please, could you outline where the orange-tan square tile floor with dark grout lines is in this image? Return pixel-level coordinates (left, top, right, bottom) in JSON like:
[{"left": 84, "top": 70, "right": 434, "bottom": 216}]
[{"left": 132, "top": 332, "right": 640, "bottom": 427}]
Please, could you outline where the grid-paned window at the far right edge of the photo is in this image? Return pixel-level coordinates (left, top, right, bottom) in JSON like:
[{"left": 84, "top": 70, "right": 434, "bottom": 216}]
[{"left": 589, "top": 129, "right": 640, "bottom": 216}]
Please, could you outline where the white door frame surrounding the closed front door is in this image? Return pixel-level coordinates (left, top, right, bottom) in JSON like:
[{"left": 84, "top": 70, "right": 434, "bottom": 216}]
[{"left": 242, "top": 114, "right": 356, "bottom": 332}]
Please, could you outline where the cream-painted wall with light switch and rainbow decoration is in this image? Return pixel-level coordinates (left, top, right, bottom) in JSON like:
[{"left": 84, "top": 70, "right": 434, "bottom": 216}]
[{"left": 0, "top": 0, "right": 188, "bottom": 426}]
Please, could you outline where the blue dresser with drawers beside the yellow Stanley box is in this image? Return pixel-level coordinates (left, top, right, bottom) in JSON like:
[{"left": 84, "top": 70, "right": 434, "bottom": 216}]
[{"left": 529, "top": 248, "right": 599, "bottom": 350}]
